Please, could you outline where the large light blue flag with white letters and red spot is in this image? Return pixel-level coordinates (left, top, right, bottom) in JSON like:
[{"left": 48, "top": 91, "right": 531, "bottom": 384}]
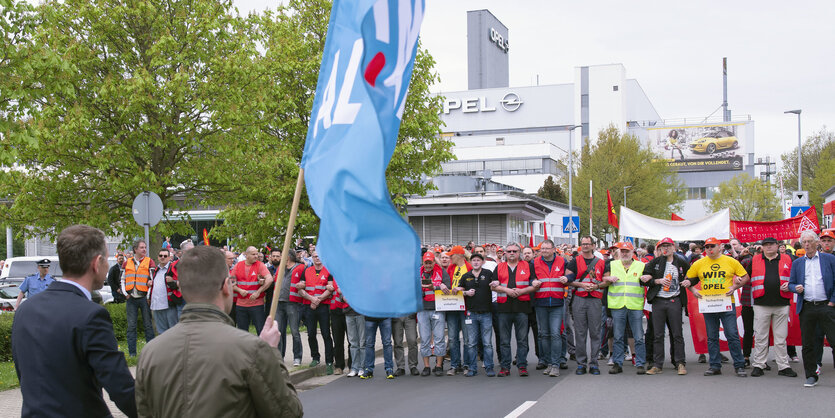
[{"left": 302, "top": 0, "right": 424, "bottom": 318}]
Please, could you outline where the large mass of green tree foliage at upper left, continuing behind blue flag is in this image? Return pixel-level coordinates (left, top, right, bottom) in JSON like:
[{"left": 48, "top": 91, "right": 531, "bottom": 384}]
[{"left": 0, "top": 0, "right": 451, "bottom": 250}]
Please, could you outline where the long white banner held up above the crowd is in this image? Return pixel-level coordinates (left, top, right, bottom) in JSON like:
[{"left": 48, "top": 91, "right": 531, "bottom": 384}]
[{"left": 619, "top": 206, "right": 731, "bottom": 241}]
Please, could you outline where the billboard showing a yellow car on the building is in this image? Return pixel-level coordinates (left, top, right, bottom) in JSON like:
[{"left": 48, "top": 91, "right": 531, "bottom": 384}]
[{"left": 647, "top": 122, "right": 748, "bottom": 171}]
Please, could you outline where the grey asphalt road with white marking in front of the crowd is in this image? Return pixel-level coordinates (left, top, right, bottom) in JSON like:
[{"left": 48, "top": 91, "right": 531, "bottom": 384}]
[{"left": 299, "top": 320, "right": 835, "bottom": 418}]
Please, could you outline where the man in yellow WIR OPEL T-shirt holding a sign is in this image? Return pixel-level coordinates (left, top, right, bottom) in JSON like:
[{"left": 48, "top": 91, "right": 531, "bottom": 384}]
[{"left": 687, "top": 237, "right": 749, "bottom": 377}]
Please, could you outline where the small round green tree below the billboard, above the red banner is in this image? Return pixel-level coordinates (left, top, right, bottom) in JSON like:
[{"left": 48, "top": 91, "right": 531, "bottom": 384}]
[{"left": 705, "top": 173, "right": 782, "bottom": 222}]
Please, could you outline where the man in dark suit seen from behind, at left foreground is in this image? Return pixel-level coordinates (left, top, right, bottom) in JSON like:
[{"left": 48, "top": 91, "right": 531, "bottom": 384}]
[{"left": 12, "top": 225, "right": 137, "bottom": 417}]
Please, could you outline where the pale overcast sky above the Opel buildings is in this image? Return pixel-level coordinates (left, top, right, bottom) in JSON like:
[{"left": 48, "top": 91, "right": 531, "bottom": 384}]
[{"left": 233, "top": 0, "right": 835, "bottom": 170}]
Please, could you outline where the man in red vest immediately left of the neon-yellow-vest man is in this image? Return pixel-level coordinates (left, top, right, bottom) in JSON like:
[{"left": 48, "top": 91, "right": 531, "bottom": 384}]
[{"left": 565, "top": 236, "right": 606, "bottom": 375}]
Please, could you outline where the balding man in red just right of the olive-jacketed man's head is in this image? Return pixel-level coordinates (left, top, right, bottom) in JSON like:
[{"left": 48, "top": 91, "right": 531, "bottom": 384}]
[{"left": 232, "top": 246, "right": 273, "bottom": 334}]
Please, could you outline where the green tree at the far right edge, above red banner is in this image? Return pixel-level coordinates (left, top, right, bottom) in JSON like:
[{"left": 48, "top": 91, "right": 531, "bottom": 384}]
[{"left": 780, "top": 126, "right": 835, "bottom": 221}]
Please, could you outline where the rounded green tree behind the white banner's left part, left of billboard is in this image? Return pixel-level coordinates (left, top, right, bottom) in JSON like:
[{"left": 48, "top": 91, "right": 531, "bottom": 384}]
[{"left": 561, "top": 125, "right": 684, "bottom": 237}]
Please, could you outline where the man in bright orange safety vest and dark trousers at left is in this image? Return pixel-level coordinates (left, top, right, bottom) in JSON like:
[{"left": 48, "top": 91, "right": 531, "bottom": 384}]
[{"left": 122, "top": 240, "right": 156, "bottom": 357}]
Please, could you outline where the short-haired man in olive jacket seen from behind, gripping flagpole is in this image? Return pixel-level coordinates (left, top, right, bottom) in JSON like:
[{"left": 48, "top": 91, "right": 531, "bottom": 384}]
[{"left": 136, "top": 247, "right": 303, "bottom": 417}]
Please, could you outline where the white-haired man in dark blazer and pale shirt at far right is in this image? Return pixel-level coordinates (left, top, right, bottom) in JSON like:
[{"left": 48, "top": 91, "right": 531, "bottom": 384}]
[{"left": 789, "top": 231, "right": 835, "bottom": 387}]
